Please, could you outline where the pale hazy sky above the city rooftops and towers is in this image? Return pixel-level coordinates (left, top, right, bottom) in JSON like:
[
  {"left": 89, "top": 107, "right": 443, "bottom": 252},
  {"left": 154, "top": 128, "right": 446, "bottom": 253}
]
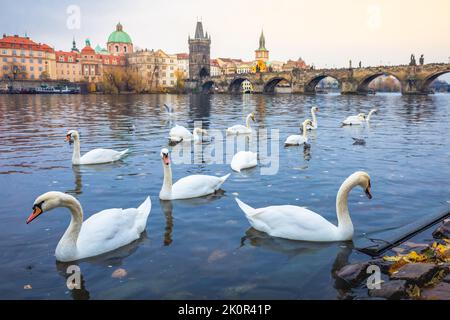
[{"left": 0, "top": 0, "right": 450, "bottom": 73}]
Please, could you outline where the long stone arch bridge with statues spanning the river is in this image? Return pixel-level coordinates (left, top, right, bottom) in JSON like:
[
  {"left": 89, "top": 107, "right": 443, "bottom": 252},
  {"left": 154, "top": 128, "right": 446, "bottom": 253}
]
[{"left": 198, "top": 63, "right": 450, "bottom": 94}]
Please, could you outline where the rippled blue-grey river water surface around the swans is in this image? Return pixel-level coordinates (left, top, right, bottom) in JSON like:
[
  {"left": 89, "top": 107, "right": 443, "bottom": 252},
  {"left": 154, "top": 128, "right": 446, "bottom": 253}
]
[{"left": 0, "top": 94, "right": 450, "bottom": 299}]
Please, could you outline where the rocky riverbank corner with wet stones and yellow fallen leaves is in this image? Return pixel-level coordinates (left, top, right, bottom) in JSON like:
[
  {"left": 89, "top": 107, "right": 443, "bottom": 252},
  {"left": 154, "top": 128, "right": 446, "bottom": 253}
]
[{"left": 335, "top": 219, "right": 450, "bottom": 300}]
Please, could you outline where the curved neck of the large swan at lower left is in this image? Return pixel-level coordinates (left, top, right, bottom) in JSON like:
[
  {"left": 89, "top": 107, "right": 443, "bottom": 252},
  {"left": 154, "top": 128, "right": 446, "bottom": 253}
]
[{"left": 58, "top": 197, "right": 83, "bottom": 253}]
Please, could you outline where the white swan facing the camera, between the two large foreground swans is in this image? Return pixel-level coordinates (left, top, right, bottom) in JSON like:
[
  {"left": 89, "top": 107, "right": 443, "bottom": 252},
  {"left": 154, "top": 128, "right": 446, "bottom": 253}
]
[{"left": 159, "top": 148, "right": 230, "bottom": 200}]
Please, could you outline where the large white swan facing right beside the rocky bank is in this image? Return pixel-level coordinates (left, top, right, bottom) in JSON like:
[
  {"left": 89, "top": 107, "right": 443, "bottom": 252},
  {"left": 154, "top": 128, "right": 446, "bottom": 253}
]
[{"left": 236, "top": 171, "right": 372, "bottom": 242}]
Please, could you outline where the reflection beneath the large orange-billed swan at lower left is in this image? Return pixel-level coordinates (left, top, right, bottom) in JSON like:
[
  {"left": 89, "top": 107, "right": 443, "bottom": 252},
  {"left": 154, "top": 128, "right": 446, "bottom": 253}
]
[{"left": 55, "top": 231, "right": 147, "bottom": 300}]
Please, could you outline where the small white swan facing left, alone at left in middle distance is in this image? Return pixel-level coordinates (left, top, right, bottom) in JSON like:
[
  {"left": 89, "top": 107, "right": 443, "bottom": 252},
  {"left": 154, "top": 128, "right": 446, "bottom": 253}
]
[{"left": 66, "top": 130, "right": 128, "bottom": 165}]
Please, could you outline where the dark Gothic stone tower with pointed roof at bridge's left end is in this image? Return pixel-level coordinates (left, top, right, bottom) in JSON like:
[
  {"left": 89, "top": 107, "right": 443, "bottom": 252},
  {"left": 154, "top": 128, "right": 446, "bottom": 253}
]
[{"left": 188, "top": 21, "right": 211, "bottom": 80}]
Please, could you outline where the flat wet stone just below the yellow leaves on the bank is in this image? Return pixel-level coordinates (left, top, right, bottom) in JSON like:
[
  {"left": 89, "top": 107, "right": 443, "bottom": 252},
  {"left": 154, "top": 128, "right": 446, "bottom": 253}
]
[{"left": 391, "top": 263, "right": 439, "bottom": 286}]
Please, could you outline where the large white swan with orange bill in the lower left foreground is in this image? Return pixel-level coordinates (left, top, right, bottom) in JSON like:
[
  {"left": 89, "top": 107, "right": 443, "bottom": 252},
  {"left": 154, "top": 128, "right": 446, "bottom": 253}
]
[{"left": 27, "top": 191, "right": 152, "bottom": 262}]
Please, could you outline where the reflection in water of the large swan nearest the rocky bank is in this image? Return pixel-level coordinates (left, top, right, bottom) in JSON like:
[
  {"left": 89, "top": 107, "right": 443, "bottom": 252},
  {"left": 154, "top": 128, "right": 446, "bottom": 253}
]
[{"left": 240, "top": 227, "right": 354, "bottom": 299}]
